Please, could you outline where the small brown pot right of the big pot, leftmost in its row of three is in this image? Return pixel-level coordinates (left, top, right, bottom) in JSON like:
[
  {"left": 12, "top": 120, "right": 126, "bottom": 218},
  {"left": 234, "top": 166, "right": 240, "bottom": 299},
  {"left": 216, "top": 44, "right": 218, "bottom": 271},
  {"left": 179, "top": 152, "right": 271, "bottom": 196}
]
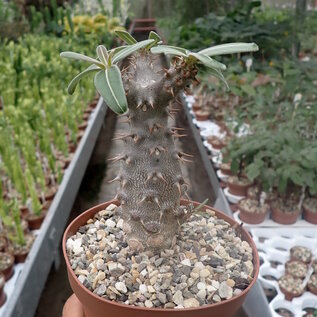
[{"left": 238, "top": 198, "right": 269, "bottom": 224}]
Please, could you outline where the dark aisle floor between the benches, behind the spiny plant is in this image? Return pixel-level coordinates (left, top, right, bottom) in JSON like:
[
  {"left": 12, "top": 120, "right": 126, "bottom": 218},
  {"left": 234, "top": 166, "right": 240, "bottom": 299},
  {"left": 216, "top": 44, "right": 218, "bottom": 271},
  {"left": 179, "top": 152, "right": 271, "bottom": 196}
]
[{"left": 35, "top": 107, "right": 246, "bottom": 317}]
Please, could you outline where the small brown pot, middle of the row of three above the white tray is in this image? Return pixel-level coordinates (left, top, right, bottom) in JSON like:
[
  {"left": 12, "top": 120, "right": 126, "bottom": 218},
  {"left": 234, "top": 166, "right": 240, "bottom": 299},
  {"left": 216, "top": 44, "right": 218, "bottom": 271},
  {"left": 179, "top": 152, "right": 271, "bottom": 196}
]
[{"left": 271, "top": 198, "right": 301, "bottom": 225}]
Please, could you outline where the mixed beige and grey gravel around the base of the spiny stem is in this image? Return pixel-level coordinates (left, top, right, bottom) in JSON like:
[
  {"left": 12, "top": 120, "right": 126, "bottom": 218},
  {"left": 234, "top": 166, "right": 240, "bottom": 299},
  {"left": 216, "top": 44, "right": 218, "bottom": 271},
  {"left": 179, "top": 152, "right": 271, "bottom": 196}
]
[{"left": 66, "top": 205, "right": 254, "bottom": 308}]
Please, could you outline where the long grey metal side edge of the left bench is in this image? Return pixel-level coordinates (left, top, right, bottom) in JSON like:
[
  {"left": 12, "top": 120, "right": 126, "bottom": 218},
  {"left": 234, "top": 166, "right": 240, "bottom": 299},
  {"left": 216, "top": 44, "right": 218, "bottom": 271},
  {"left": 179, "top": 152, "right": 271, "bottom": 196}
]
[{"left": 0, "top": 98, "right": 107, "bottom": 317}]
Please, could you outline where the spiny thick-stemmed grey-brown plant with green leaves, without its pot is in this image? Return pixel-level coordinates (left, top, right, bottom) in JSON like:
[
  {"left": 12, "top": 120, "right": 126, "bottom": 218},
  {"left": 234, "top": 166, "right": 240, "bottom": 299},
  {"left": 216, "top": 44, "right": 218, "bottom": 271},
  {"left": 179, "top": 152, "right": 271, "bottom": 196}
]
[{"left": 61, "top": 31, "right": 258, "bottom": 251}]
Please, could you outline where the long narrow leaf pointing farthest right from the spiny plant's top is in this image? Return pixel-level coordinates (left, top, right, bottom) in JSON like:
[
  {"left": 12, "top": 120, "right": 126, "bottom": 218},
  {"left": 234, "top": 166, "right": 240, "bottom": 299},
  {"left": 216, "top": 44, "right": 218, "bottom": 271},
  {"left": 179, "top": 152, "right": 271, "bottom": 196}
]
[{"left": 198, "top": 43, "right": 259, "bottom": 56}]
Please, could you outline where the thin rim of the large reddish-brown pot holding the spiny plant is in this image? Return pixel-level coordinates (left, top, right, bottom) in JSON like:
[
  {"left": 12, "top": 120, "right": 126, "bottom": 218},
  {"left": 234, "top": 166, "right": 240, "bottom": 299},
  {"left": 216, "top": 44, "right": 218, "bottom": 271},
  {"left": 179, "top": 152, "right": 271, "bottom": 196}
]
[{"left": 62, "top": 199, "right": 260, "bottom": 312}]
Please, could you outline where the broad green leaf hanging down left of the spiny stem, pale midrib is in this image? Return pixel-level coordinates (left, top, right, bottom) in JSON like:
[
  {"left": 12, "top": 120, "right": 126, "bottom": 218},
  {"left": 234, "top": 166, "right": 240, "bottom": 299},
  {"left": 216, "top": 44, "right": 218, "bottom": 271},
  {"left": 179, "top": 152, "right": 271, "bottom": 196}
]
[{"left": 95, "top": 65, "right": 128, "bottom": 114}]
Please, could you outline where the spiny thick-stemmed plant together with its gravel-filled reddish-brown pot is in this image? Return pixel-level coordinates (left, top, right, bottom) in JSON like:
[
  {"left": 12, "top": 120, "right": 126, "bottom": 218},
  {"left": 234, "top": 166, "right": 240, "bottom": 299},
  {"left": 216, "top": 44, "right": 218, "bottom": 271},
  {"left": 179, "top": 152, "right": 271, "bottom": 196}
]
[{"left": 61, "top": 32, "right": 259, "bottom": 317}]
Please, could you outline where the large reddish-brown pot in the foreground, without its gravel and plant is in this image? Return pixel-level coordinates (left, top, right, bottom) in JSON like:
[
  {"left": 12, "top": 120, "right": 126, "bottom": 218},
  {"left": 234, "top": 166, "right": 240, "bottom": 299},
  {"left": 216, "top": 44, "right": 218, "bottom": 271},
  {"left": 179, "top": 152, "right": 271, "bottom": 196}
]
[{"left": 63, "top": 201, "right": 259, "bottom": 317}]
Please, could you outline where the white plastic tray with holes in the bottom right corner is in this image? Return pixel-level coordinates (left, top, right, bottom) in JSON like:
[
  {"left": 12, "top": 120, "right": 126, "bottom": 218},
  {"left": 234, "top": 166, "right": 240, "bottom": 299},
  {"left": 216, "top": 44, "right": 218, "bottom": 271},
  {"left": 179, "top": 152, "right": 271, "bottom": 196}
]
[{"left": 250, "top": 226, "right": 317, "bottom": 317}]
